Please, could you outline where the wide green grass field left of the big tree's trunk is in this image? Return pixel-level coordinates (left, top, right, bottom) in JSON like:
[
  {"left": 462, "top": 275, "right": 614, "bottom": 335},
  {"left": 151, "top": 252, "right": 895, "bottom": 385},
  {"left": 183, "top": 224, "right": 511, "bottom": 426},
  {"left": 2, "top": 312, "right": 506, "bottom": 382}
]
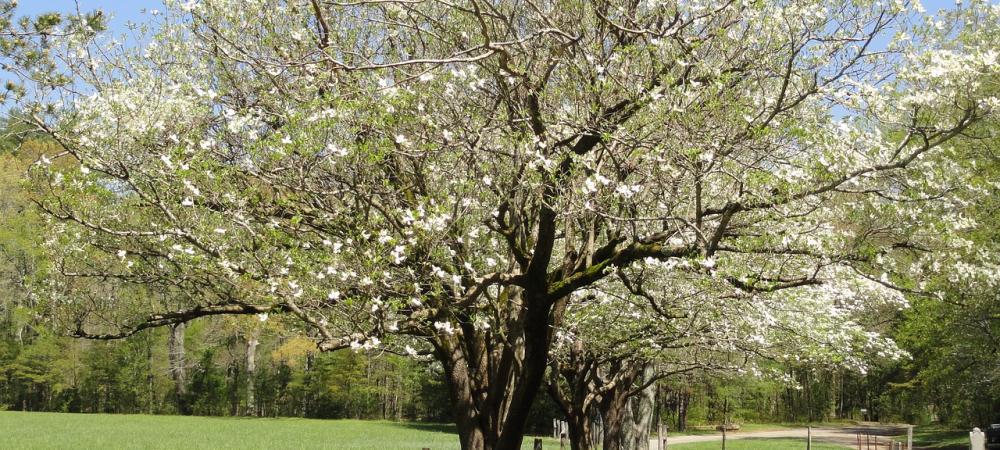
[{"left": 0, "top": 411, "right": 559, "bottom": 450}]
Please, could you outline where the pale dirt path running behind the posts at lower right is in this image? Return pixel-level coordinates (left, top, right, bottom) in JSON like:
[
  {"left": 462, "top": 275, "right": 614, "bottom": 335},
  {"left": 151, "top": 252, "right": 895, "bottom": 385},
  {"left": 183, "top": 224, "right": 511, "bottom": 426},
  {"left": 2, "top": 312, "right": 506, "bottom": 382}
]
[{"left": 650, "top": 425, "right": 906, "bottom": 450}]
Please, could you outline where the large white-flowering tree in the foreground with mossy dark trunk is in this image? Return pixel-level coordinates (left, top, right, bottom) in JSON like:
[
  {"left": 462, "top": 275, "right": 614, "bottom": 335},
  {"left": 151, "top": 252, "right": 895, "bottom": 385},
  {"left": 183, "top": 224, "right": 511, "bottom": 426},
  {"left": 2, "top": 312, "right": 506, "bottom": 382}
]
[{"left": 3, "top": 0, "right": 1000, "bottom": 449}]
